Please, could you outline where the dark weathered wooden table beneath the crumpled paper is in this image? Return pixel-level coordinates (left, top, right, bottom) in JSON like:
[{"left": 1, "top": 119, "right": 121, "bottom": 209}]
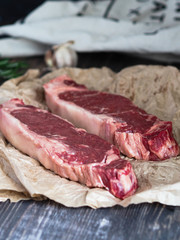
[{"left": 0, "top": 52, "right": 180, "bottom": 240}]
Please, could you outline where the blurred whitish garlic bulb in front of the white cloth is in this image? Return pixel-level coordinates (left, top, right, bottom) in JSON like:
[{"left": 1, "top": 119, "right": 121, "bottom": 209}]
[{"left": 45, "top": 41, "right": 78, "bottom": 68}]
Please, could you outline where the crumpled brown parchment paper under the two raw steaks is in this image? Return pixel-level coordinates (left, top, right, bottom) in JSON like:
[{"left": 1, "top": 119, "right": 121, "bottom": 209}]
[{"left": 0, "top": 65, "right": 180, "bottom": 208}]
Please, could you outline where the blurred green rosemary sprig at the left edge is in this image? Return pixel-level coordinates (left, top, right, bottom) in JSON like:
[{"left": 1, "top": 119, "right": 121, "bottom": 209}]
[{"left": 0, "top": 58, "right": 28, "bottom": 80}]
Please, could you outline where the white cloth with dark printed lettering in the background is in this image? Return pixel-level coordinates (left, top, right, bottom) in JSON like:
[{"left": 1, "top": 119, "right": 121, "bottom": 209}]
[{"left": 0, "top": 0, "right": 180, "bottom": 61}]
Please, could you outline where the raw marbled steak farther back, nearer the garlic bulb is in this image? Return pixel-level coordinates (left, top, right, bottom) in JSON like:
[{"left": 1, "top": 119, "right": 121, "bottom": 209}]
[{"left": 44, "top": 76, "right": 179, "bottom": 160}]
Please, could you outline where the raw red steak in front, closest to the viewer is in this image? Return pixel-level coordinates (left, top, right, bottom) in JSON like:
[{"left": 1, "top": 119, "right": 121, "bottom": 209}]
[{"left": 0, "top": 99, "right": 137, "bottom": 199}]
